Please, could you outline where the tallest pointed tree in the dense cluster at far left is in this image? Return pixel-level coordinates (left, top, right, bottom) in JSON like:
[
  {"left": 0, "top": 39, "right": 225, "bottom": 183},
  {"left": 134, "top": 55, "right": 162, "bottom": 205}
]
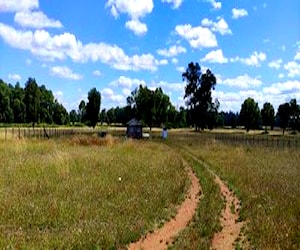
[{"left": 24, "top": 78, "right": 41, "bottom": 127}]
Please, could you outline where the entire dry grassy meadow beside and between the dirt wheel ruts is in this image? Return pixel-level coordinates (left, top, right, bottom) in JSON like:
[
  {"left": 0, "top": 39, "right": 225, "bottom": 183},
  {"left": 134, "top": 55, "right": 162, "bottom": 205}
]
[{"left": 0, "top": 130, "right": 300, "bottom": 249}]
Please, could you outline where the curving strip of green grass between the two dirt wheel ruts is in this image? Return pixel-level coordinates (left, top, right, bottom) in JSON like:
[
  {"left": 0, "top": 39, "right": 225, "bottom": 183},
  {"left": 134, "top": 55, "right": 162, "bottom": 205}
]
[{"left": 165, "top": 141, "right": 224, "bottom": 249}]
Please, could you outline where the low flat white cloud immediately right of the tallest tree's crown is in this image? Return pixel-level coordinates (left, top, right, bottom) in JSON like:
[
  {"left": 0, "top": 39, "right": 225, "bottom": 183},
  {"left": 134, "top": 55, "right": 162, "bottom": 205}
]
[{"left": 218, "top": 74, "right": 262, "bottom": 89}]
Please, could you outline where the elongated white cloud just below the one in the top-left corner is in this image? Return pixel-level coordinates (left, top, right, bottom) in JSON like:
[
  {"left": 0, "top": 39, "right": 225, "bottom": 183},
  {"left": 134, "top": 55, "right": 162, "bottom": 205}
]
[{"left": 14, "top": 11, "right": 63, "bottom": 29}]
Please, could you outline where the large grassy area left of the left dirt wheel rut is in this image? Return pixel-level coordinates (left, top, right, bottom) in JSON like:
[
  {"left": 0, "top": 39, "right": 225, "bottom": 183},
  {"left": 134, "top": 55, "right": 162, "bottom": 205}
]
[{"left": 0, "top": 137, "right": 188, "bottom": 249}]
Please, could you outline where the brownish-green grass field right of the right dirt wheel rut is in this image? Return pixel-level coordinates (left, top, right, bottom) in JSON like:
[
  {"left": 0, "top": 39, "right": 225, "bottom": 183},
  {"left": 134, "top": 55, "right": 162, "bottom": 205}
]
[{"left": 170, "top": 133, "right": 300, "bottom": 249}]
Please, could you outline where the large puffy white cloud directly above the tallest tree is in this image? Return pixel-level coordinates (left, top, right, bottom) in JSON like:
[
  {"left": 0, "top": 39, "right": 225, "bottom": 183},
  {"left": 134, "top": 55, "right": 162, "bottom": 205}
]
[{"left": 175, "top": 24, "right": 218, "bottom": 49}]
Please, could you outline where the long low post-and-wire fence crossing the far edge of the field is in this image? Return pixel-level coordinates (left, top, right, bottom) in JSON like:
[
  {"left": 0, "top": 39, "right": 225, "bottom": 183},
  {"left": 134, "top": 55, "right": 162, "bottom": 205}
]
[{"left": 0, "top": 127, "right": 300, "bottom": 148}]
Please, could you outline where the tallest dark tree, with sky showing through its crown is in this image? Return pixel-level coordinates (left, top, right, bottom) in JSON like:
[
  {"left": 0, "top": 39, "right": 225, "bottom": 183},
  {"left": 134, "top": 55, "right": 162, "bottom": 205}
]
[{"left": 182, "top": 62, "right": 218, "bottom": 131}]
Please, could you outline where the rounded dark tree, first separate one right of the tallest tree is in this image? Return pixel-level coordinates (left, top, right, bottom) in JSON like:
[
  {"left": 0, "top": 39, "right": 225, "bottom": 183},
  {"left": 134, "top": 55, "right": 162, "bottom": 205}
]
[{"left": 240, "top": 97, "right": 260, "bottom": 132}]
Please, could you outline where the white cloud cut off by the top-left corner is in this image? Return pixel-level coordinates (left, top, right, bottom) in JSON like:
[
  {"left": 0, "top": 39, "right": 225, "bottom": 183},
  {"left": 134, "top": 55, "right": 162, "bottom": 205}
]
[{"left": 0, "top": 0, "right": 39, "bottom": 12}]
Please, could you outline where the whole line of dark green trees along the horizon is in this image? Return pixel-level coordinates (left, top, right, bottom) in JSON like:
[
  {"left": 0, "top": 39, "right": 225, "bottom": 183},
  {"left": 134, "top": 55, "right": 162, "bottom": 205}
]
[{"left": 0, "top": 62, "right": 300, "bottom": 133}]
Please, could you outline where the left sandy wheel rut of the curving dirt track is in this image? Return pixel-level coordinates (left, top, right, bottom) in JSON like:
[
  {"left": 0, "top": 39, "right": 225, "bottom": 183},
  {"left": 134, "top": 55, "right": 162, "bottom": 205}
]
[{"left": 128, "top": 168, "right": 201, "bottom": 250}]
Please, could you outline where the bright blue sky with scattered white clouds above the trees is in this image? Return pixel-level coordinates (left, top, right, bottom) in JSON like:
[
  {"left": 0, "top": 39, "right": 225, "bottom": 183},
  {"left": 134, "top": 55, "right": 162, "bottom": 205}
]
[{"left": 0, "top": 0, "right": 300, "bottom": 111}]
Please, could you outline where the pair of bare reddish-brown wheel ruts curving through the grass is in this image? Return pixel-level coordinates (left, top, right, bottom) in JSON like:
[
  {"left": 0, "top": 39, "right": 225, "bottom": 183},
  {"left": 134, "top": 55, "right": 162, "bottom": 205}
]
[{"left": 128, "top": 150, "right": 244, "bottom": 250}]
